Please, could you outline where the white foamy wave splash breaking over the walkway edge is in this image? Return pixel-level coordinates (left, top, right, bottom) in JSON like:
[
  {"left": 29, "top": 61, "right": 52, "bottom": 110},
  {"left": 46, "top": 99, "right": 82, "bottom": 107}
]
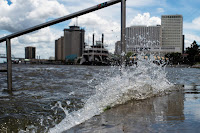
[{"left": 49, "top": 55, "right": 173, "bottom": 133}]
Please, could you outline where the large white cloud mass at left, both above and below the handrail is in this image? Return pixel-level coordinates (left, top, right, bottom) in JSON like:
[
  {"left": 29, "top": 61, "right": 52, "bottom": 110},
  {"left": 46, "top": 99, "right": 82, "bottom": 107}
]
[{"left": 0, "top": 0, "right": 68, "bottom": 58}]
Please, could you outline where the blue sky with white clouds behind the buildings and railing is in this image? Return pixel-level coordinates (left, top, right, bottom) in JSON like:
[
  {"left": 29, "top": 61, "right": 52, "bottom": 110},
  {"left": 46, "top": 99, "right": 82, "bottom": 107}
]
[{"left": 0, "top": 0, "right": 200, "bottom": 59}]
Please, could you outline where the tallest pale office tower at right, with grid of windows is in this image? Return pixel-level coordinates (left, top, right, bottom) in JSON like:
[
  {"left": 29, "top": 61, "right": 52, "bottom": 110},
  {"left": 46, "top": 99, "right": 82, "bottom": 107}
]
[{"left": 161, "top": 15, "right": 184, "bottom": 53}]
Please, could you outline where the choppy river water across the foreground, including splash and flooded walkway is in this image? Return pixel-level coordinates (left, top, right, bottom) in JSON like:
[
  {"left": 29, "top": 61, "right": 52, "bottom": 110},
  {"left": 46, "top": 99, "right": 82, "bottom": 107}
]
[{"left": 0, "top": 57, "right": 200, "bottom": 133}]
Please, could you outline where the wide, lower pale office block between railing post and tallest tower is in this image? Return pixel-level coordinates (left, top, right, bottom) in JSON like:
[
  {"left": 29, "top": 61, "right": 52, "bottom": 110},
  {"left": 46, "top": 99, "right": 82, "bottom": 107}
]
[{"left": 126, "top": 25, "right": 161, "bottom": 52}]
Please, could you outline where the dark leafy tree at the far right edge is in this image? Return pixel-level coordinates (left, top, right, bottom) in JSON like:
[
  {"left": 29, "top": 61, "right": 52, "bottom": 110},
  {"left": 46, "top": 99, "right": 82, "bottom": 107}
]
[{"left": 186, "top": 41, "right": 200, "bottom": 65}]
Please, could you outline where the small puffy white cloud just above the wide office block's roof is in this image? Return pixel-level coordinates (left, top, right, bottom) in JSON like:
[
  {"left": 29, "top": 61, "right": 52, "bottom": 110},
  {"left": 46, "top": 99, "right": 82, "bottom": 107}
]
[{"left": 130, "top": 13, "right": 161, "bottom": 26}]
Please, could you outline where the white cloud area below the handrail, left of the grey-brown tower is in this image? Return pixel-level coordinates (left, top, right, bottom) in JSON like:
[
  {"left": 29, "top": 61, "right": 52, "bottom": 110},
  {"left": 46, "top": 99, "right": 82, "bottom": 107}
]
[{"left": 0, "top": 27, "right": 63, "bottom": 59}]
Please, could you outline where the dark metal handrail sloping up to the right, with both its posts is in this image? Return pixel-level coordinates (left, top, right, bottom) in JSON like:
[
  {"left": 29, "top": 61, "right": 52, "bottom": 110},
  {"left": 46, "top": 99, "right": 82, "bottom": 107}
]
[{"left": 0, "top": 0, "right": 126, "bottom": 92}]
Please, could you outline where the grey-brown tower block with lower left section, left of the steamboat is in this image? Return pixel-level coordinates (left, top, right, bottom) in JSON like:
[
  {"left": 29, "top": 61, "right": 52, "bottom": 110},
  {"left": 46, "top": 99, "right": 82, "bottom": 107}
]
[{"left": 55, "top": 26, "right": 85, "bottom": 61}]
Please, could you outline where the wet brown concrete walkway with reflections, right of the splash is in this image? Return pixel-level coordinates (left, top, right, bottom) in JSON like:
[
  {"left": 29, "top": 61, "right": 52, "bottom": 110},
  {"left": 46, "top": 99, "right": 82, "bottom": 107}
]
[{"left": 68, "top": 87, "right": 200, "bottom": 133}]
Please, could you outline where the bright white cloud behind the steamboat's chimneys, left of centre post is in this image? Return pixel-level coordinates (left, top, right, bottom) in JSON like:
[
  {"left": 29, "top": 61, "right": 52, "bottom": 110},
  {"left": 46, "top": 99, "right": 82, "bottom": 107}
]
[{"left": 69, "top": 13, "right": 121, "bottom": 52}]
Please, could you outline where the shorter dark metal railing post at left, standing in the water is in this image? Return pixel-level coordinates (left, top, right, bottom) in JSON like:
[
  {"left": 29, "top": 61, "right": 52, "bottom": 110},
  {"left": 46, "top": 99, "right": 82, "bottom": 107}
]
[{"left": 6, "top": 38, "right": 12, "bottom": 92}]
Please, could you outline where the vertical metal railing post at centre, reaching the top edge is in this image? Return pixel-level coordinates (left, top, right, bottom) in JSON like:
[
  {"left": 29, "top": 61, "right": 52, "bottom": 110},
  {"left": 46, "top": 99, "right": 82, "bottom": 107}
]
[{"left": 121, "top": 0, "right": 126, "bottom": 62}]
